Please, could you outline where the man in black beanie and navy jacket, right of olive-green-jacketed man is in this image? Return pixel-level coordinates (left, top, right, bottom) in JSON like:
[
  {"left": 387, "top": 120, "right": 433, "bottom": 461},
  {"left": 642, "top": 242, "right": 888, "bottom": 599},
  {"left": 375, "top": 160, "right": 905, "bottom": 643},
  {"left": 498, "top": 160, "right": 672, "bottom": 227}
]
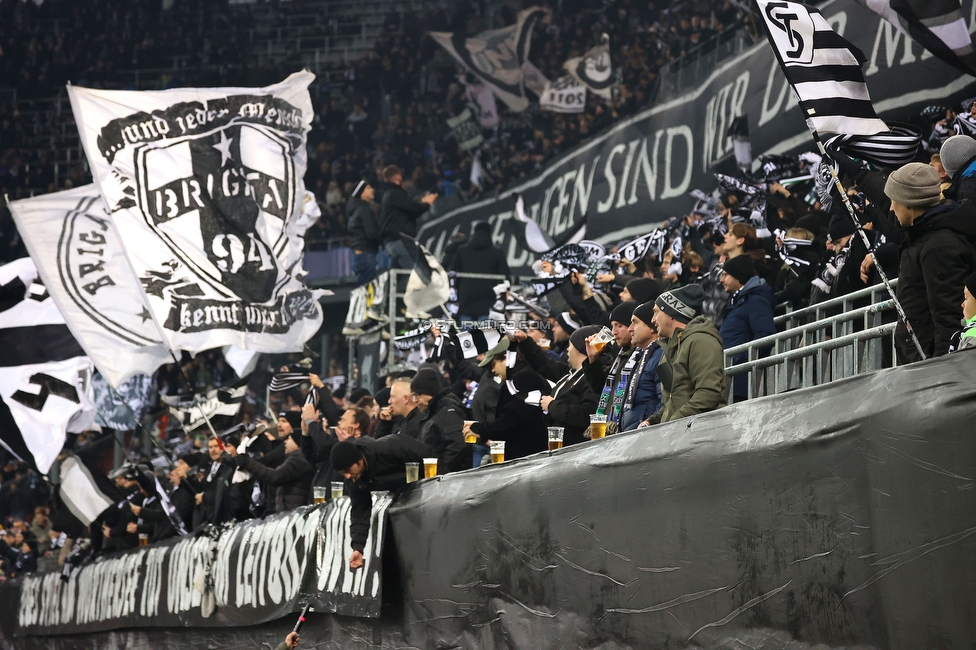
[{"left": 719, "top": 254, "right": 772, "bottom": 402}]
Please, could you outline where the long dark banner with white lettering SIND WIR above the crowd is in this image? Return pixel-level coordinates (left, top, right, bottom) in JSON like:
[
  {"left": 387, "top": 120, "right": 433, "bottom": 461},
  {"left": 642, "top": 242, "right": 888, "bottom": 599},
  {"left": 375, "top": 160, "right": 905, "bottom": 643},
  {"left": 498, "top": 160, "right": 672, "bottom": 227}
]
[{"left": 418, "top": 0, "right": 976, "bottom": 271}]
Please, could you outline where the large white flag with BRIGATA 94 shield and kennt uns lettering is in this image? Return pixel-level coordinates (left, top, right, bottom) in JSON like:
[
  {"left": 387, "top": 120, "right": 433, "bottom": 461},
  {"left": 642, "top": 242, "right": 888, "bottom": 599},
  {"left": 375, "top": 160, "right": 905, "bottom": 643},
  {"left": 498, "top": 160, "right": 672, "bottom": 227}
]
[{"left": 68, "top": 71, "right": 322, "bottom": 353}]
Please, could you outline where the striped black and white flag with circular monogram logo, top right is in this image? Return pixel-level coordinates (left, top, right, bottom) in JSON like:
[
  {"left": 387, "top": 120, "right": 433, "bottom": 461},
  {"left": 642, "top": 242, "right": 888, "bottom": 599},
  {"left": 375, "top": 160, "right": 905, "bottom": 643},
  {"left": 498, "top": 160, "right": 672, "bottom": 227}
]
[{"left": 756, "top": 0, "right": 888, "bottom": 135}]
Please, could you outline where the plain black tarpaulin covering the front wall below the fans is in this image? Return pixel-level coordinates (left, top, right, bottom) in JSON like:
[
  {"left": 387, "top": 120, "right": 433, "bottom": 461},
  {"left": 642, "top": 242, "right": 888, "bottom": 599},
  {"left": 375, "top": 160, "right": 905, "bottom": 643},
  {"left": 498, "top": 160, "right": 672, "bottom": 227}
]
[{"left": 0, "top": 351, "right": 976, "bottom": 650}]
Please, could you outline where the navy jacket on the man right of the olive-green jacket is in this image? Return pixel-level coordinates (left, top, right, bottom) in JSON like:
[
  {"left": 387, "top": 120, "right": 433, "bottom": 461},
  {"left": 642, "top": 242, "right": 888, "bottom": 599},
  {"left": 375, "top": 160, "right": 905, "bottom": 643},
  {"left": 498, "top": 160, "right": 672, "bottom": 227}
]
[{"left": 719, "top": 276, "right": 776, "bottom": 397}]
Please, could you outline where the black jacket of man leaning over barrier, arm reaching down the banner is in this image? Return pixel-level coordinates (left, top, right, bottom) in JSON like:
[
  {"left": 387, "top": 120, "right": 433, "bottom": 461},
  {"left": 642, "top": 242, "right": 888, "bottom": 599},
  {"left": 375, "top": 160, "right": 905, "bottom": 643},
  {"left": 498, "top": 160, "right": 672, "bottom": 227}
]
[{"left": 346, "top": 436, "right": 430, "bottom": 553}]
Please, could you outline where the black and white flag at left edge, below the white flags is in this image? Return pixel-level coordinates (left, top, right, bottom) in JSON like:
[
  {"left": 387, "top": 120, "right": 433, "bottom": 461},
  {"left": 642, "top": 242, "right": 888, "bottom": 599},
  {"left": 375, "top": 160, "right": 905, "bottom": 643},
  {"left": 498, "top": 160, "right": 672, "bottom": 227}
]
[{"left": 0, "top": 257, "right": 95, "bottom": 474}]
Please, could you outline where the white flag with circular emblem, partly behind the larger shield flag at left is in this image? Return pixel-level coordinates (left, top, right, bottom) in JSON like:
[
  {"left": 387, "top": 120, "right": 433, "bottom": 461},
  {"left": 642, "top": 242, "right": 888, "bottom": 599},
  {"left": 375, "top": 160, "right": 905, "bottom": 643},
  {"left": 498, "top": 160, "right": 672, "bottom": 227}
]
[{"left": 10, "top": 185, "right": 172, "bottom": 388}]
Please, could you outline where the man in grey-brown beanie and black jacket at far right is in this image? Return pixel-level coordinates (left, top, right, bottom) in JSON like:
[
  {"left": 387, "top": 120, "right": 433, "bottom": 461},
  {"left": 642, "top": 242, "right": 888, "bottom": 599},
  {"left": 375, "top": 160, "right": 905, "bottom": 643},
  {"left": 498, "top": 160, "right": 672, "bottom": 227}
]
[{"left": 885, "top": 163, "right": 976, "bottom": 363}]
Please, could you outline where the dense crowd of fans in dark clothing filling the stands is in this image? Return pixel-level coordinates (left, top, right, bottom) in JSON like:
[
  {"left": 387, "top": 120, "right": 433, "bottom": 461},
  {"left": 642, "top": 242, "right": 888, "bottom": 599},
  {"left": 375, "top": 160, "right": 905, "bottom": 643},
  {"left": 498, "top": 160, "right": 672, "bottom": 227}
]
[{"left": 0, "top": 0, "right": 976, "bottom": 578}]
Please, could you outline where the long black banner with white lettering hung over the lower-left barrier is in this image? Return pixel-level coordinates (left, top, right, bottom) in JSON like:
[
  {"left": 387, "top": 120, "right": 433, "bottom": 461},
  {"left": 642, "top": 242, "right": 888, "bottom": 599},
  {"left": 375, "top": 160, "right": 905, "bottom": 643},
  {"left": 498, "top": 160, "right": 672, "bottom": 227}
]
[{"left": 0, "top": 493, "right": 392, "bottom": 636}]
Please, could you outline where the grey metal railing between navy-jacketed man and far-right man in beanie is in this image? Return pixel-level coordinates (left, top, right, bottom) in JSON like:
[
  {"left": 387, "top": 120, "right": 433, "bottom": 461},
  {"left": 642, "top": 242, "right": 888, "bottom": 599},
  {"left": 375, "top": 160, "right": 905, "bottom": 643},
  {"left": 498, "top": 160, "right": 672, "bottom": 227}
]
[{"left": 725, "top": 280, "right": 897, "bottom": 399}]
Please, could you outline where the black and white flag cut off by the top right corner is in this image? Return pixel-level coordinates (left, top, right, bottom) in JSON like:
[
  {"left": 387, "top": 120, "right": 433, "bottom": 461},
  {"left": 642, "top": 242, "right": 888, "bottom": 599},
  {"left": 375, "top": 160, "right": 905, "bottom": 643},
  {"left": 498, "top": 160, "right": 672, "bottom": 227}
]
[{"left": 857, "top": 0, "right": 976, "bottom": 76}]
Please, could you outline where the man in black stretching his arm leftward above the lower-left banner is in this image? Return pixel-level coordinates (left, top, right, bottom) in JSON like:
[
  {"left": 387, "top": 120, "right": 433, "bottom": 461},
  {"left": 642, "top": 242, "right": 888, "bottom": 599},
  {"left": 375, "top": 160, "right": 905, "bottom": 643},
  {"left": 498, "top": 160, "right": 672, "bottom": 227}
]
[{"left": 227, "top": 418, "right": 315, "bottom": 512}]
